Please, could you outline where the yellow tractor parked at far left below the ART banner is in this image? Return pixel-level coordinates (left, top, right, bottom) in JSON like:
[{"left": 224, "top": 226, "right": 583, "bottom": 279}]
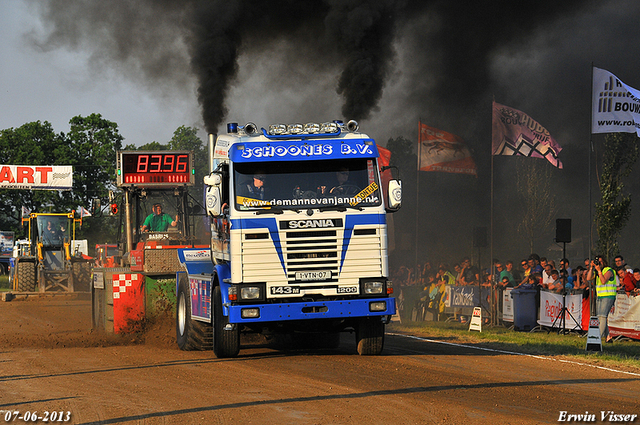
[{"left": 11, "top": 212, "right": 91, "bottom": 292}]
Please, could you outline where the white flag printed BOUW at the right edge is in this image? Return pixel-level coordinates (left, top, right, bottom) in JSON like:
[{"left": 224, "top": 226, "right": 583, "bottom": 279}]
[{"left": 591, "top": 67, "right": 640, "bottom": 136}]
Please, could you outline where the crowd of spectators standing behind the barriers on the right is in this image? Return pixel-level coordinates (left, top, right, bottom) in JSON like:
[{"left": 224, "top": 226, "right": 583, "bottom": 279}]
[{"left": 392, "top": 254, "right": 640, "bottom": 322}]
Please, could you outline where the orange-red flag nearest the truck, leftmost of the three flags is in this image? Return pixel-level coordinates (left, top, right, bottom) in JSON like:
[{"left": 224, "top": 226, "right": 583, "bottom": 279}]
[{"left": 418, "top": 123, "right": 477, "bottom": 176}]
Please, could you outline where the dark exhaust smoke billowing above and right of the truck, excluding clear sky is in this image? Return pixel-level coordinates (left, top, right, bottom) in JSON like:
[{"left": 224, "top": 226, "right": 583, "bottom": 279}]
[{"left": 25, "top": 0, "right": 640, "bottom": 265}]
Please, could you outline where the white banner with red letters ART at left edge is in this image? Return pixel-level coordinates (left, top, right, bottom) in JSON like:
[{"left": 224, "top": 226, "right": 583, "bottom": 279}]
[{"left": 0, "top": 165, "right": 73, "bottom": 190}]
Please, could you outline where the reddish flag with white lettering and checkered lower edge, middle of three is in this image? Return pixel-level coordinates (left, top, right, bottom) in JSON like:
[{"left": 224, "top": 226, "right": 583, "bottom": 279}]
[{"left": 492, "top": 102, "right": 562, "bottom": 168}]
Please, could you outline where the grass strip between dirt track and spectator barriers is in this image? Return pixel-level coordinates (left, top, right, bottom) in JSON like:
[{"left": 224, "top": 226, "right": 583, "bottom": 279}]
[{"left": 387, "top": 321, "right": 640, "bottom": 372}]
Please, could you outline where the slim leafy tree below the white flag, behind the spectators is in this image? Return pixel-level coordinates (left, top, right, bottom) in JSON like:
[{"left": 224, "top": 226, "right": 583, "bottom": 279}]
[{"left": 596, "top": 133, "right": 638, "bottom": 260}]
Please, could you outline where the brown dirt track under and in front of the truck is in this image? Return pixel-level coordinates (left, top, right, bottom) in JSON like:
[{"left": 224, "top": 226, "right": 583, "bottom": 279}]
[{"left": 0, "top": 299, "right": 640, "bottom": 424}]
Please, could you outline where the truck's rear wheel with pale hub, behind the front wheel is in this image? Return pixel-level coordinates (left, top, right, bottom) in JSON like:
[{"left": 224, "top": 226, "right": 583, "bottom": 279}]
[{"left": 176, "top": 274, "right": 213, "bottom": 351}]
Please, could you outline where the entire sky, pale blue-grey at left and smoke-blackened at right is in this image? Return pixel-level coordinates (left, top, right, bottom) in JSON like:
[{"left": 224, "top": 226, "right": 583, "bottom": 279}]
[{"left": 0, "top": 0, "right": 640, "bottom": 261}]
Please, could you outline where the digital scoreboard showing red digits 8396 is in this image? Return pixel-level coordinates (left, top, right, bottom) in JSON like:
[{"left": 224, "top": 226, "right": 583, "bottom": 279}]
[{"left": 117, "top": 151, "right": 195, "bottom": 187}]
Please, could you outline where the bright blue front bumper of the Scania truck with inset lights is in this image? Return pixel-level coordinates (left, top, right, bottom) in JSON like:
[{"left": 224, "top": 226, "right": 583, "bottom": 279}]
[{"left": 228, "top": 297, "right": 396, "bottom": 323}]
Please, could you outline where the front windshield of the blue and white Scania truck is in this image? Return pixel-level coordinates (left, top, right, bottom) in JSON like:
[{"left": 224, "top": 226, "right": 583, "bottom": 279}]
[{"left": 234, "top": 158, "right": 381, "bottom": 210}]
